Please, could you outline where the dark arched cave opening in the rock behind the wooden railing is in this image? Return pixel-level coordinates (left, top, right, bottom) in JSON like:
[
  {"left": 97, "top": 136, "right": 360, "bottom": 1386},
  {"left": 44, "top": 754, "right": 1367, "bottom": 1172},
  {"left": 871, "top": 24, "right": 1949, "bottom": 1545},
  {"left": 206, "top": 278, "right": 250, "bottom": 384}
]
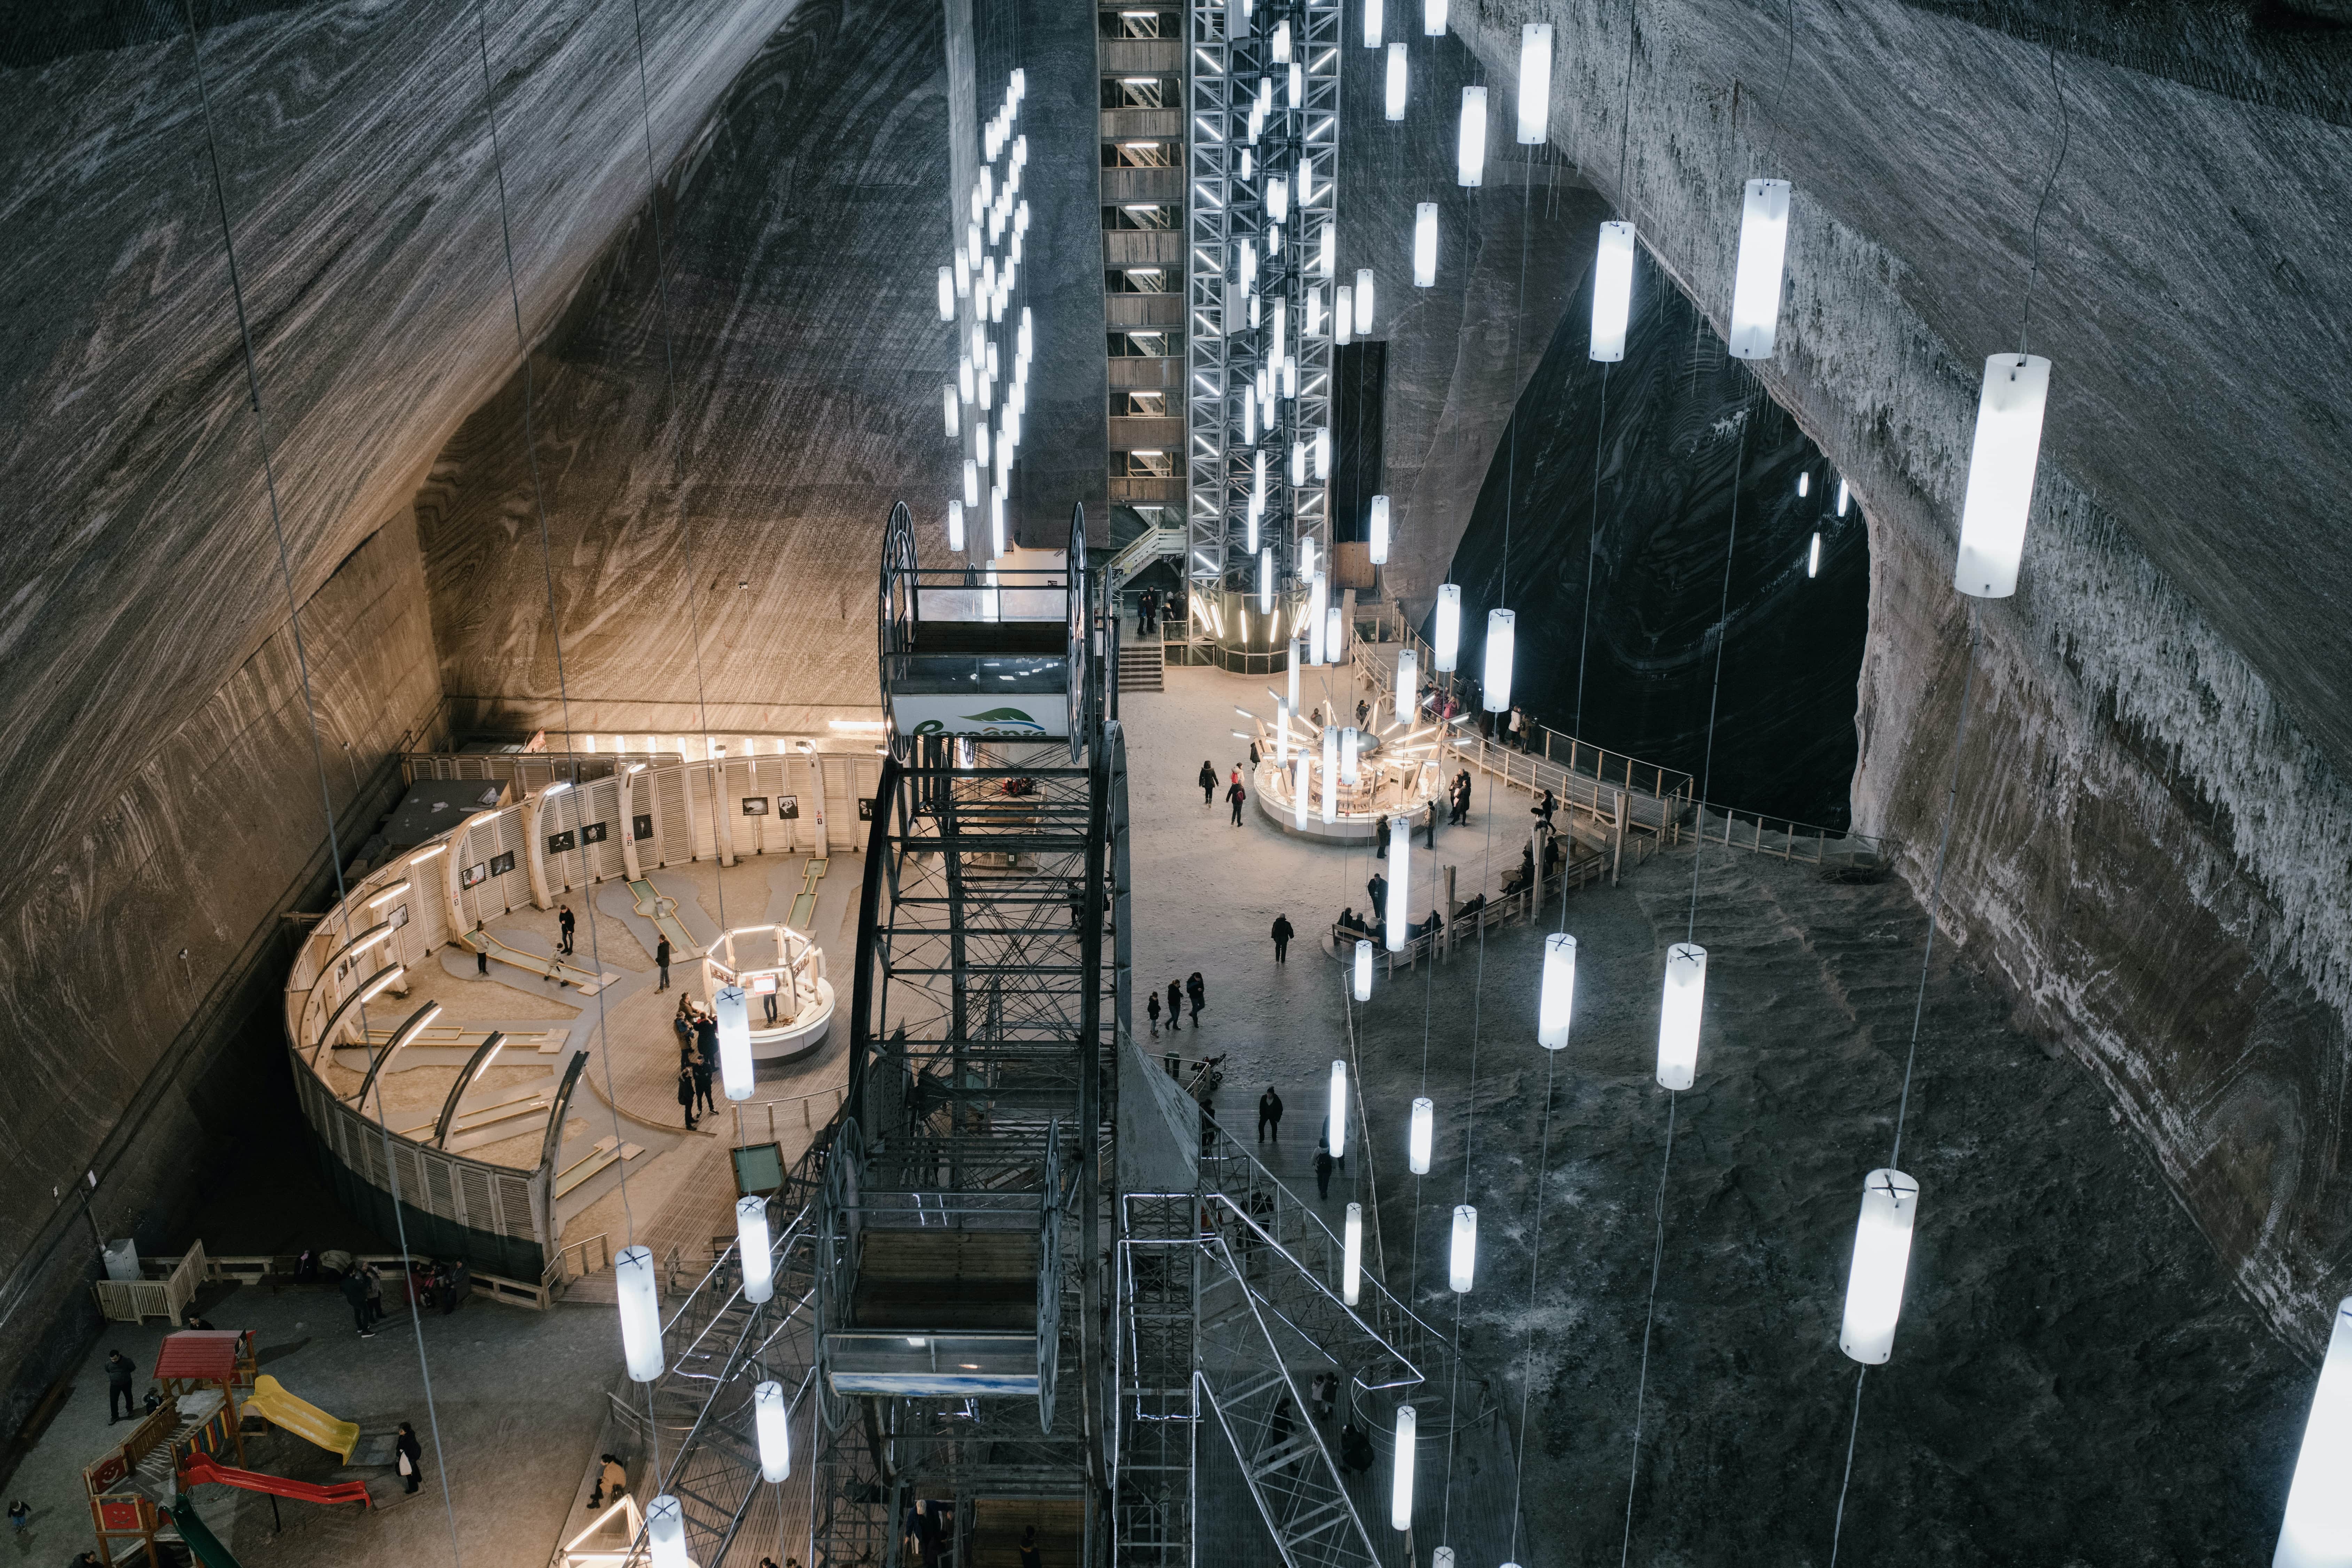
[{"left": 1451, "top": 252, "right": 1870, "bottom": 830}]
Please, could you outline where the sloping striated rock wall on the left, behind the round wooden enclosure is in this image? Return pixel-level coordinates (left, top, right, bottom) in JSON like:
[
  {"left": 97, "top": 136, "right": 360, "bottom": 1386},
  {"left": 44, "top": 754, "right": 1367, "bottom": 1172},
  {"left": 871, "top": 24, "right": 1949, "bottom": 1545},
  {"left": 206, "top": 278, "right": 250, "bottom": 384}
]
[{"left": 0, "top": 0, "right": 788, "bottom": 1429}]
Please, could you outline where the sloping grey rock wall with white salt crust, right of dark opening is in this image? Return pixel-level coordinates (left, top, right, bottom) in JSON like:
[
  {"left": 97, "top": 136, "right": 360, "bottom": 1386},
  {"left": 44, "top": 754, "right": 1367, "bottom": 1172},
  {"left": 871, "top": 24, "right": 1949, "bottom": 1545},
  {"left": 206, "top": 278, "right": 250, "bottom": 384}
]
[{"left": 1463, "top": 0, "right": 2352, "bottom": 1352}]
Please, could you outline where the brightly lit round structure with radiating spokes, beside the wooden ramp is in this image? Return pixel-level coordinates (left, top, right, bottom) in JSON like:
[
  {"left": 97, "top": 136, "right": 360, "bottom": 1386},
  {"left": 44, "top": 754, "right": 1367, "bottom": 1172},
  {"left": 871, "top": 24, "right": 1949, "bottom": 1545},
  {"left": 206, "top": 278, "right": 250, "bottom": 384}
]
[{"left": 1232, "top": 689, "right": 1447, "bottom": 844}]
